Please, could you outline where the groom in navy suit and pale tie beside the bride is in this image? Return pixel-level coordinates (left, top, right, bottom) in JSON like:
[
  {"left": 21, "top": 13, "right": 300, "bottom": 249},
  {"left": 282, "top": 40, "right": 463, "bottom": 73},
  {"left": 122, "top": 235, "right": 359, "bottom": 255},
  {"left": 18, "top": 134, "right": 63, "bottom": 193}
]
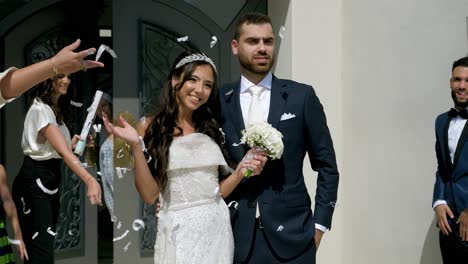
[{"left": 220, "top": 13, "right": 339, "bottom": 264}]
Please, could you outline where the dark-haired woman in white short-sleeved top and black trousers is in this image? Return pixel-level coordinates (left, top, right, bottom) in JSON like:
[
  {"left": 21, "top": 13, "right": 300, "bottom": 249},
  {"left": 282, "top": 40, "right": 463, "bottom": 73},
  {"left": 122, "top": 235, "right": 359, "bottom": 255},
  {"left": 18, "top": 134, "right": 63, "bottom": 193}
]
[{"left": 13, "top": 74, "right": 101, "bottom": 264}]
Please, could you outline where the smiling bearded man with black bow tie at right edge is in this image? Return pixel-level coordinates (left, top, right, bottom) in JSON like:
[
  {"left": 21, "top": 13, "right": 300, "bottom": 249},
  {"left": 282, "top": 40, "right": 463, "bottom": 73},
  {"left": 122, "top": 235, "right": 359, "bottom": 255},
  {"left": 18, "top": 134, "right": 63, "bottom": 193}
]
[{"left": 433, "top": 57, "right": 468, "bottom": 264}]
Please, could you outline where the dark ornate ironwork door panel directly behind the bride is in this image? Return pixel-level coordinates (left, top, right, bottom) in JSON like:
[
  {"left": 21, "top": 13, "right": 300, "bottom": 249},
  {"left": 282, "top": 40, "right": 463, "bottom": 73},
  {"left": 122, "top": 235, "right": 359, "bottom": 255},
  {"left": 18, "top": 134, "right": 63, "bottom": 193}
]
[{"left": 140, "top": 22, "right": 196, "bottom": 255}]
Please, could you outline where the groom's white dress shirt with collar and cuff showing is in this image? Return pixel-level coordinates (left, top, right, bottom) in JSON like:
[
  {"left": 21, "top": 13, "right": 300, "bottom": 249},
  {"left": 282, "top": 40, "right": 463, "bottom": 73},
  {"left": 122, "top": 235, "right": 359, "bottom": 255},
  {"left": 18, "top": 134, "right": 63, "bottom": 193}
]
[{"left": 240, "top": 72, "right": 328, "bottom": 232}]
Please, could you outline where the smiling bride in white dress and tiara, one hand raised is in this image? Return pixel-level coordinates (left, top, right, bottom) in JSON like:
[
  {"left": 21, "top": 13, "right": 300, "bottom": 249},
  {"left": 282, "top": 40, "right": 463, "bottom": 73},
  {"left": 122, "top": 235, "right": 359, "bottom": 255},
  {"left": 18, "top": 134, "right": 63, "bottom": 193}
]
[{"left": 104, "top": 52, "right": 266, "bottom": 264}]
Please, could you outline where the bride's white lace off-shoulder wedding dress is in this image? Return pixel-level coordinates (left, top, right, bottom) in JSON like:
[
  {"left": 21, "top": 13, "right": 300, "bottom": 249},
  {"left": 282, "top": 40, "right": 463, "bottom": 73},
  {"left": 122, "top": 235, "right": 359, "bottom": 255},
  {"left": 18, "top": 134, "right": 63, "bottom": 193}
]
[{"left": 154, "top": 133, "right": 234, "bottom": 264}]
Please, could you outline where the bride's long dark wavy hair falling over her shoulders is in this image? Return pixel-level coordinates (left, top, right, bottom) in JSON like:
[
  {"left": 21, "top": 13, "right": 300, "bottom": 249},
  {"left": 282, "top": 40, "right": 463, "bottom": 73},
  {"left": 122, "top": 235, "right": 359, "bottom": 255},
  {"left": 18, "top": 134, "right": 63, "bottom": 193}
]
[{"left": 144, "top": 51, "right": 229, "bottom": 192}]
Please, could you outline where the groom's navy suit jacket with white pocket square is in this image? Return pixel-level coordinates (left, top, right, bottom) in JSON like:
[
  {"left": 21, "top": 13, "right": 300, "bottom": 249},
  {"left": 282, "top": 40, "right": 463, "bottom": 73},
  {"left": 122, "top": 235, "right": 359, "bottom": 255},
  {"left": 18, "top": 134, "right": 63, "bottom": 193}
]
[{"left": 220, "top": 77, "right": 339, "bottom": 261}]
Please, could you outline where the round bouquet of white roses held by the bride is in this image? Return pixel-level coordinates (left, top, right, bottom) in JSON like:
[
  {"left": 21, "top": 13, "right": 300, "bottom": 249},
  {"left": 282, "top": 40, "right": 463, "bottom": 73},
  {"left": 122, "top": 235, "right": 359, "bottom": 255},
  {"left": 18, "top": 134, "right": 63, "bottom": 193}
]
[{"left": 241, "top": 122, "right": 284, "bottom": 178}]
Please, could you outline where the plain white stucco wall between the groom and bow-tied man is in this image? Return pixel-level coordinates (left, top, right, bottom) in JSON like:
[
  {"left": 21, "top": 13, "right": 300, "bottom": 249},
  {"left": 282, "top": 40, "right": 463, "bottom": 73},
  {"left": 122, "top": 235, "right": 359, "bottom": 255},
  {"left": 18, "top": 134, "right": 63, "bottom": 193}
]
[{"left": 269, "top": 0, "right": 468, "bottom": 264}]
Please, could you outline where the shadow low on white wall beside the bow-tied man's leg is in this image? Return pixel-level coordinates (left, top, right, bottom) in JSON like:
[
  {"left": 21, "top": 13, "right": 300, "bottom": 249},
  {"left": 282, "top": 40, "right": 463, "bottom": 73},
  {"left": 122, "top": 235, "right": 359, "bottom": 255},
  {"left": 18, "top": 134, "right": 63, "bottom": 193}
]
[{"left": 419, "top": 216, "right": 442, "bottom": 264}]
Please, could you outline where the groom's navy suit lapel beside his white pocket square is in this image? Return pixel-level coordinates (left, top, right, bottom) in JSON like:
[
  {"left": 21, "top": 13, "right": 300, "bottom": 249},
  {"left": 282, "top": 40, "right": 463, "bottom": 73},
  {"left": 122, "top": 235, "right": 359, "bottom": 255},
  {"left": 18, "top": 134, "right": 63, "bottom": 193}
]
[{"left": 268, "top": 76, "right": 288, "bottom": 128}]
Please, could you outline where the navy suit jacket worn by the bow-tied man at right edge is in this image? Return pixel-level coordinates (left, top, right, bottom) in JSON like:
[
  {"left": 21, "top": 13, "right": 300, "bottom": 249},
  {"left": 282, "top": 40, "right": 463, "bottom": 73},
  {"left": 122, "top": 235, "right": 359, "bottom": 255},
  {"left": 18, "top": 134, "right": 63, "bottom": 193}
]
[{"left": 432, "top": 112, "right": 468, "bottom": 225}]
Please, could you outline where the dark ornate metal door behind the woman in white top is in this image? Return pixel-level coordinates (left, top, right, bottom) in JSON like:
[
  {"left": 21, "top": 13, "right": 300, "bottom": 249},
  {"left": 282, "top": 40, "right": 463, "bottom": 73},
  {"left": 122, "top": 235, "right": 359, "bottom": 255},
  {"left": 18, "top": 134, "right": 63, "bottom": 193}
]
[{"left": 0, "top": 0, "right": 106, "bottom": 263}]
